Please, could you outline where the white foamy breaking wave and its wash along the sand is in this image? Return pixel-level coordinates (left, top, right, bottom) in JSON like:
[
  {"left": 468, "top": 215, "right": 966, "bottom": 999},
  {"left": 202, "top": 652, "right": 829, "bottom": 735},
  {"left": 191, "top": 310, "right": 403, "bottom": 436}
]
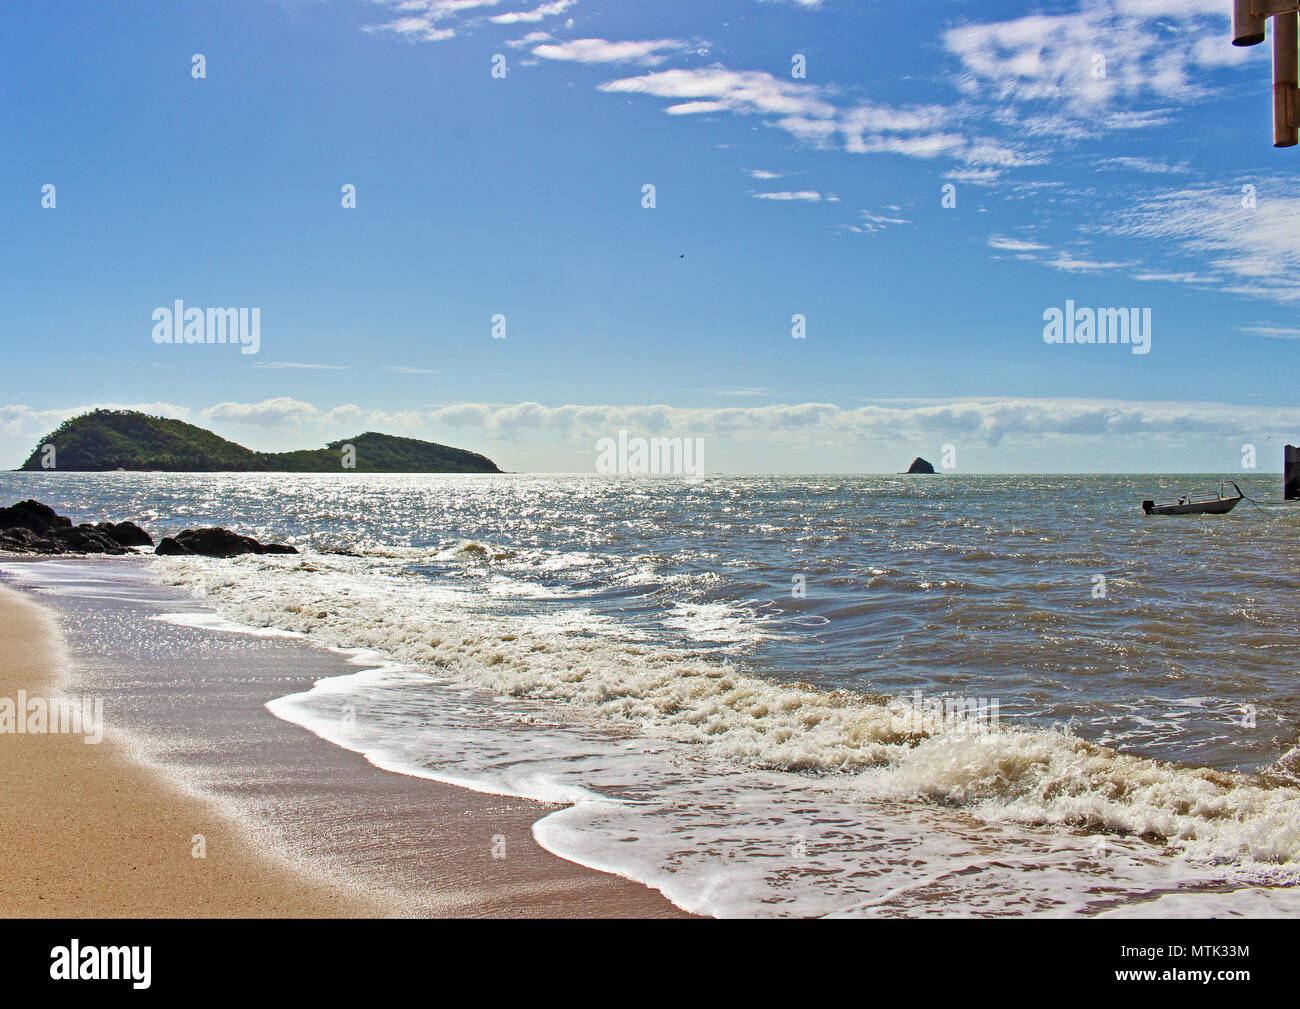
[{"left": 157, "top": 557, "right": 1300, "bottom": 913}]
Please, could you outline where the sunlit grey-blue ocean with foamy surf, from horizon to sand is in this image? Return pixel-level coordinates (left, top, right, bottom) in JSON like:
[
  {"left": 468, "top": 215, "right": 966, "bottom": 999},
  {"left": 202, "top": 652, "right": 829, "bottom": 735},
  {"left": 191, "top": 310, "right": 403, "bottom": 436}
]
[{"left": 0, "top": 473, "right": 1300, "bottom": 917}]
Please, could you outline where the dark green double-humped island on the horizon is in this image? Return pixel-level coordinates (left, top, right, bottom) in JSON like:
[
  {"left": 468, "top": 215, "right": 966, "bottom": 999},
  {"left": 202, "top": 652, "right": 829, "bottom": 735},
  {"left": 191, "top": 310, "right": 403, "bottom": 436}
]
[{"left": 20, "top": 410, "right": 501, "bottom": 473}]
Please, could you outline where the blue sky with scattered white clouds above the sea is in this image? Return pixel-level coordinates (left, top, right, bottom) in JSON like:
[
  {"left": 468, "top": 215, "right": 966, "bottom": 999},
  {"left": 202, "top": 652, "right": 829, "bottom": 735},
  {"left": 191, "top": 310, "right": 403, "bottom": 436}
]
[{"left": 0, "top": 0, "right": 1300, "bottom": 472}]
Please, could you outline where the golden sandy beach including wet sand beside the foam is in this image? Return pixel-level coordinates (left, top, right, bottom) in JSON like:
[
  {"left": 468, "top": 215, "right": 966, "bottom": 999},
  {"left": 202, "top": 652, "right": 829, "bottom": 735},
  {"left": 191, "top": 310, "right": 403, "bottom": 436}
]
[{"left": 0, "top": 572, "right": 692, "bottom": 918}]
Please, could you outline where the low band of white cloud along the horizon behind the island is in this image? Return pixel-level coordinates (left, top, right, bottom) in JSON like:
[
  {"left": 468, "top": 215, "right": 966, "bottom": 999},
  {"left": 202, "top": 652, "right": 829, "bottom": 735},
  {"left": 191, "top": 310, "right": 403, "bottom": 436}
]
[{"left": 0, "top": 397, "right": 1300, "bottom": 472}]
